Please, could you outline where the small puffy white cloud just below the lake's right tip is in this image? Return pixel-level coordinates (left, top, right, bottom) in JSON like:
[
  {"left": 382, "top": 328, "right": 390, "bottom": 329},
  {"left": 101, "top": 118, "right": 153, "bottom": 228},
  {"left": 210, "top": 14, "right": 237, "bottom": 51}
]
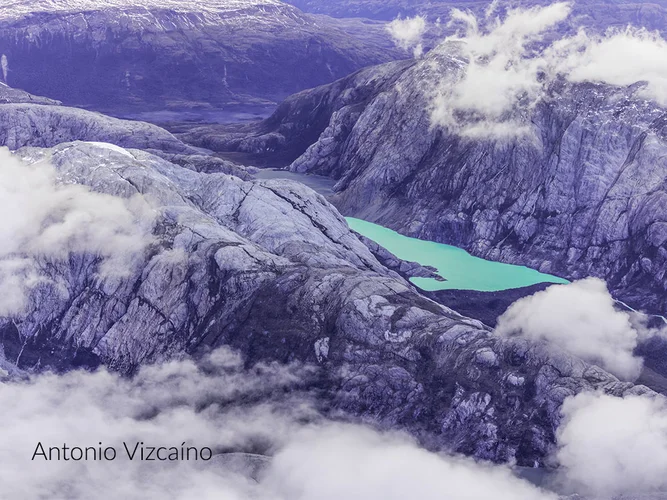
[{"left": 496, "top": 278, "right": 643, "bottom": 380}]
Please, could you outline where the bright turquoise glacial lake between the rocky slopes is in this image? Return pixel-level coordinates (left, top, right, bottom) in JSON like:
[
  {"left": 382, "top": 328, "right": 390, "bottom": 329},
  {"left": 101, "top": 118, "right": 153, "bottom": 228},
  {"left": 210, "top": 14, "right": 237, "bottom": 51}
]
[{"left": 346, "top": 217, "right": 569, "bottom": 292}]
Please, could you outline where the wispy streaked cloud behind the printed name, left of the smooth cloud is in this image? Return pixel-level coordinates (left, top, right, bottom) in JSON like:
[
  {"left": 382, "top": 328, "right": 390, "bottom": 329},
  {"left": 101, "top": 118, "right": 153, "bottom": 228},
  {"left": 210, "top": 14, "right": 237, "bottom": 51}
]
[{"left": 0, "top": 350, "right": 314, "bottom": 500}]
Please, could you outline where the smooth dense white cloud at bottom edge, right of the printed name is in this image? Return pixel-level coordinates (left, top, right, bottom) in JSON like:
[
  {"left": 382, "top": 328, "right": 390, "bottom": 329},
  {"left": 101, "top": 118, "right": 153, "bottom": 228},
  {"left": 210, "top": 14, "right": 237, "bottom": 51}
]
[{"left": 266, "top": 426, "right": 556, "bottom": 500}]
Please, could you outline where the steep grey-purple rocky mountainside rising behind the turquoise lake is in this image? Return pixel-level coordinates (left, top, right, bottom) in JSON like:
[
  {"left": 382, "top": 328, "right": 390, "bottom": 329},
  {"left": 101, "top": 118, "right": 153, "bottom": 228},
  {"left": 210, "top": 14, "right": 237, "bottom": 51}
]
[{"left": 201, "top": 46, "right": 667, "bottom": 314}]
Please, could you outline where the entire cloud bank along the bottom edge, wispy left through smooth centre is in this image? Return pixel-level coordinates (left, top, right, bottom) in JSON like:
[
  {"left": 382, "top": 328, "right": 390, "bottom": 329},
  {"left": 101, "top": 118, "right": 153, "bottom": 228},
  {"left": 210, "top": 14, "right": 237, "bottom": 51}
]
[{"left": 0, "top": 349, "right": 555, "bottom": 500}]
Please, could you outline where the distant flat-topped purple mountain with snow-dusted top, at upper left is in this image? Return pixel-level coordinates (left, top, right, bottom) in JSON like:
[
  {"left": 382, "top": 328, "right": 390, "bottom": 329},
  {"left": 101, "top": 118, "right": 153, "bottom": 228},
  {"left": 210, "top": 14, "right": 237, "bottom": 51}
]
[{"left": 0, "top": 0, "right": 400, "bottom": 114}]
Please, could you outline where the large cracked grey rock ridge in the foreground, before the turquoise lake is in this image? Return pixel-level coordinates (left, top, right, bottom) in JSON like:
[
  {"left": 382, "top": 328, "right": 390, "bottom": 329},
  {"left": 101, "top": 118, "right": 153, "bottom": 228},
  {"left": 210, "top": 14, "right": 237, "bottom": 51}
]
[{"left": 0, "top": 139, "right": 646, "bottom": 466}]
